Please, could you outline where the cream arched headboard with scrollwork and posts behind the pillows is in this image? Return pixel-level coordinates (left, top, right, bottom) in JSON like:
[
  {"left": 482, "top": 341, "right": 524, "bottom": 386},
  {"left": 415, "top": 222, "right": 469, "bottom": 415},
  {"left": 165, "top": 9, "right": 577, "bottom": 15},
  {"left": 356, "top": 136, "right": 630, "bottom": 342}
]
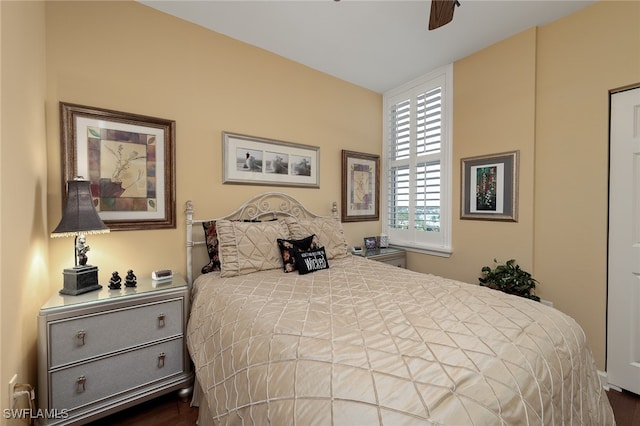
[{"left": 186, "top": 192, "right": 340, "bottom": 286}]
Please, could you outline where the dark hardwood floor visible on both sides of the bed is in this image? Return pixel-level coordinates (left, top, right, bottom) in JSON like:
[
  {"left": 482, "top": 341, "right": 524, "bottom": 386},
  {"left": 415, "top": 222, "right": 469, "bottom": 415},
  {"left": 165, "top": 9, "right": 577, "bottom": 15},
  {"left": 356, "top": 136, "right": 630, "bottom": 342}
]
[{"left": 90, "top": 390, "right": 640, "bottom": 426}]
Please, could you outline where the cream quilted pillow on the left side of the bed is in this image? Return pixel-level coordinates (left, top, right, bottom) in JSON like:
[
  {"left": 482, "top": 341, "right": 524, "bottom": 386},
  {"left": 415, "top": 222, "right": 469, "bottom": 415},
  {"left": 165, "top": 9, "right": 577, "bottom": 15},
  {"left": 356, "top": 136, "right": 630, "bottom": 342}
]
[{"left": 216, "top": 220, "right": 289, "bottom": 277}]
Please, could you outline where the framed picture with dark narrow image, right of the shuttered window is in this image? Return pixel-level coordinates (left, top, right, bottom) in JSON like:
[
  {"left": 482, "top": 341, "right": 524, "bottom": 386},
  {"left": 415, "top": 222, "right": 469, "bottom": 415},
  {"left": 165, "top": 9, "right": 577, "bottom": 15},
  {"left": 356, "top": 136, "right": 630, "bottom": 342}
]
[{"left": 460, "top": 151, "right": 519, "bottom": 222}]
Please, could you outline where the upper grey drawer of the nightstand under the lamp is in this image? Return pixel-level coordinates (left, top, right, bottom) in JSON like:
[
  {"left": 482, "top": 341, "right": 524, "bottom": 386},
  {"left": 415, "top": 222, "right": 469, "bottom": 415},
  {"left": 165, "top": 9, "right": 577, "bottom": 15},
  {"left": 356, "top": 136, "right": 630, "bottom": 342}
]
[{"left": 48, "top": 299, "right": 183, "bottom": 368}]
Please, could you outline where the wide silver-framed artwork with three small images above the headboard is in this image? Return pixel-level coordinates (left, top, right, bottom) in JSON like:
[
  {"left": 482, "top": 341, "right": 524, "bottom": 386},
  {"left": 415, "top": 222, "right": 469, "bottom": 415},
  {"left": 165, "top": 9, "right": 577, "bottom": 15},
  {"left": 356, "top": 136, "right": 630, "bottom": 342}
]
[{"left": 222, "top": 132, "right": 320, "bottom": 188}]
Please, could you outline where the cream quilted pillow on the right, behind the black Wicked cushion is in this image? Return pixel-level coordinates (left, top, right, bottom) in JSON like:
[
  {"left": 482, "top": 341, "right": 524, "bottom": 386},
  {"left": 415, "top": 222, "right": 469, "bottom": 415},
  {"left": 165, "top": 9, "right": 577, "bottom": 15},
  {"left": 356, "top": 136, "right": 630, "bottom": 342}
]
[{"left": 284, "top": 216, "right": 347, "bottom": 259}]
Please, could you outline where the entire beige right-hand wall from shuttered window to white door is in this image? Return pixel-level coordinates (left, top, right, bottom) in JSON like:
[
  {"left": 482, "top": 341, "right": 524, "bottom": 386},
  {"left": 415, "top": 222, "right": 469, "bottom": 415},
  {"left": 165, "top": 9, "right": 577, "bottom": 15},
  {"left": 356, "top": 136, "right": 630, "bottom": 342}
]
[{"left": 409, "top": 1, "right": 640, "bottom": 370}]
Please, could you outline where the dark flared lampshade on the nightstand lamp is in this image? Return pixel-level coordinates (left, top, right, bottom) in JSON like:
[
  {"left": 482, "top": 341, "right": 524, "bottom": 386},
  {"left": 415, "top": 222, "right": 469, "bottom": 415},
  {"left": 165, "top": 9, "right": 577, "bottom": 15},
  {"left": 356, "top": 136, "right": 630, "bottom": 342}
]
[{"left": 51, "top": 179, "right": 109, "bottom": 237}]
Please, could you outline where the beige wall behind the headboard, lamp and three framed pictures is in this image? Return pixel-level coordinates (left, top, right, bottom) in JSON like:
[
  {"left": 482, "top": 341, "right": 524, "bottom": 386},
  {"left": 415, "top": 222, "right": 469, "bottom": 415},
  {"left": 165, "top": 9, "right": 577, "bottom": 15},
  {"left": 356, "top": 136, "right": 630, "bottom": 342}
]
[{"left": 46, "top": 2, "right": 382, "bottom": 292}]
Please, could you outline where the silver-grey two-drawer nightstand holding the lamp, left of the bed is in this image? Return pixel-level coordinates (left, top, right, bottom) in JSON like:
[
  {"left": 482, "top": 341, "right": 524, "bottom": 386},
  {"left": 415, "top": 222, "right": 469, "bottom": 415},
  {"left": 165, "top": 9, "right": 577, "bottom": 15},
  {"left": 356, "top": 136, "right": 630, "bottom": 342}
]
[{"left": 38, "top": 275, "right": 193, "bottom": 424}]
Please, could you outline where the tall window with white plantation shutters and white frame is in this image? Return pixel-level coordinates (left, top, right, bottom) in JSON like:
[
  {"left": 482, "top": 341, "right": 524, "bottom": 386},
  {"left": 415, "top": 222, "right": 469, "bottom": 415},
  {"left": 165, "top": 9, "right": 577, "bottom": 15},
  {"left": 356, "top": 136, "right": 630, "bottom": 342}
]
[{"left": 382, "top": 65, "right": 453, "bottom": 255}]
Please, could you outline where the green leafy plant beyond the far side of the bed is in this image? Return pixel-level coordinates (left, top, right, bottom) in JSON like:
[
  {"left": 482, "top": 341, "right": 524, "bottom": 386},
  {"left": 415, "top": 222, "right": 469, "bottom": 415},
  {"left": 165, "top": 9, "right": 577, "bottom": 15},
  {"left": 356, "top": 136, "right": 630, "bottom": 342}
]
[{"left": 479, "top": 259, "right": 540, "bottom": 302}]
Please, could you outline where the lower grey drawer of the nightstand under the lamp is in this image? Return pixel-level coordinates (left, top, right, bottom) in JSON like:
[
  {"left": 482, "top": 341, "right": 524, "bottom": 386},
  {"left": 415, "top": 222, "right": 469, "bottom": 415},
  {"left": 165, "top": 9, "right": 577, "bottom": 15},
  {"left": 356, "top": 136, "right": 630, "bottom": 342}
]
[{"left": 50, "top": 338, "right": 184, "bottom": 410}]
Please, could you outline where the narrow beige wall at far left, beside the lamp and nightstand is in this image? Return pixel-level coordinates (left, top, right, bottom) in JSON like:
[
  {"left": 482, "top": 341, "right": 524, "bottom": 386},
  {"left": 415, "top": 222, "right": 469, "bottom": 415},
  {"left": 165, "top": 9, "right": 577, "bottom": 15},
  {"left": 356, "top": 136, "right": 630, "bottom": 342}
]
[{"left": 0, "top": 1, "right": 49, "bottom": 424}]
